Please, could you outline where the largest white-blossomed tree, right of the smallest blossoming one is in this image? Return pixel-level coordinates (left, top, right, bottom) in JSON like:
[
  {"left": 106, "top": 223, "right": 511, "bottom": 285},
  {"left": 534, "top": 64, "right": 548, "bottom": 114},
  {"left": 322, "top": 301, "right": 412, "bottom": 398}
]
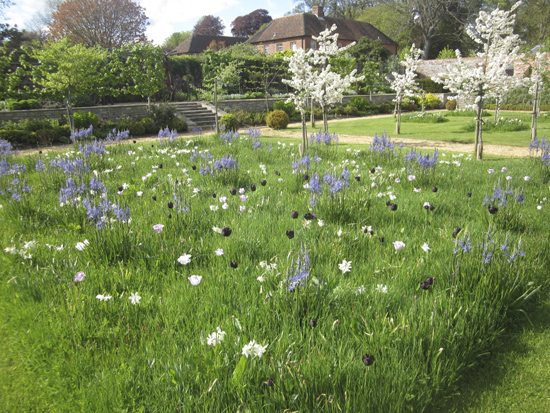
[{"left": 434, "top": 1, "right": 521, "bottom": 159}]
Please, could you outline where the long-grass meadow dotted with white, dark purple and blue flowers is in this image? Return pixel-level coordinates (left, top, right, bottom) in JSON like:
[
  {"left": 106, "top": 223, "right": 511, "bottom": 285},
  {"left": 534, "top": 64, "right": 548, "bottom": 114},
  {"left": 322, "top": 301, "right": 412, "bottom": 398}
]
[{"left": 0, "top": 115, "right": 550, "bottom": 412}]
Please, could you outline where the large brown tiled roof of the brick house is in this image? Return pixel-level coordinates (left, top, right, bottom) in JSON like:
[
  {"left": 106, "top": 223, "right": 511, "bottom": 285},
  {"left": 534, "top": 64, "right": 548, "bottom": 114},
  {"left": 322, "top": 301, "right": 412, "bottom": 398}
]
[{"left": 248, "top": 13, "right": 397, "bottom": 46}]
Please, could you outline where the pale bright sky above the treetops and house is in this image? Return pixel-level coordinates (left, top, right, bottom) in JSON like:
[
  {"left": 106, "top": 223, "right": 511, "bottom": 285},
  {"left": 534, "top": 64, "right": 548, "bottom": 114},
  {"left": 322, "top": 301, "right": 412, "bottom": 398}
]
[{"left": 4, "top": 0, "right": 295, "bottom": 45}]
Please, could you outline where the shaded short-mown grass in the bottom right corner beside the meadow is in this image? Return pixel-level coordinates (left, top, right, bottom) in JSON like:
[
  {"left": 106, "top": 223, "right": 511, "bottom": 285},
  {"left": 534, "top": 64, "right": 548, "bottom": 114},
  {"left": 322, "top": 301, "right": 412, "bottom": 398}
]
[{"left": 434, "top": 295, "right": 550, "bottom": 412}]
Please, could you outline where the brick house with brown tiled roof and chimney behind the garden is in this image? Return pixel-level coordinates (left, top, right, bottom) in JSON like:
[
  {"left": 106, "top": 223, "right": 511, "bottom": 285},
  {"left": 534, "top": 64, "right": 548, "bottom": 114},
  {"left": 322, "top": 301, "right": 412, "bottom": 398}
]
[{"left": 247, "top": 6, "right": 397, "bottom": 54}]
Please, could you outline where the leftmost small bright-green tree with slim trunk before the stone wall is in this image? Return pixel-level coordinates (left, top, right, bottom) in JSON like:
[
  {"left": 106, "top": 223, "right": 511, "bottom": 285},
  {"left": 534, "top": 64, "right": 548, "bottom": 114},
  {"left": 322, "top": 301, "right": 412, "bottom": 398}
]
[{"left": 26, "top": 39, "right": 107, "bottom": 131}]
